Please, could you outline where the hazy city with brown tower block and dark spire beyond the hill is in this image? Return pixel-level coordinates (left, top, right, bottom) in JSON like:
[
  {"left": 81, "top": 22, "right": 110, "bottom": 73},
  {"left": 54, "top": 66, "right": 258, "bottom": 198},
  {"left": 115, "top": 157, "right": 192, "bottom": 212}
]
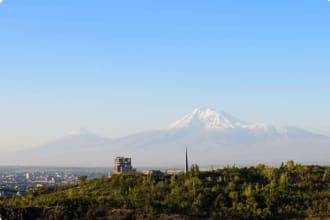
[{"left": 0, "top": 154, "right": 188, "bottom": 198}]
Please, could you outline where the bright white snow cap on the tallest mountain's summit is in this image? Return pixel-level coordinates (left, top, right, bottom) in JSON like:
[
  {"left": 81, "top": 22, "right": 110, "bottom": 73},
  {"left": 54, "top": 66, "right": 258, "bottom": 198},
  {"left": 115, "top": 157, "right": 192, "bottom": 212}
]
[{"left": 168, "top": 108, "right": 249, "bottom": 129}]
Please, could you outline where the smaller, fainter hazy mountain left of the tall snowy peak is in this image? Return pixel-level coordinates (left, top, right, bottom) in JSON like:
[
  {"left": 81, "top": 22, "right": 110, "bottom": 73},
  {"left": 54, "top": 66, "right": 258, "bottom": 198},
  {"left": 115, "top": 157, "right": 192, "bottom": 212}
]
[{"left": 4, "top": 128, "right": 112, "bottom": 166}]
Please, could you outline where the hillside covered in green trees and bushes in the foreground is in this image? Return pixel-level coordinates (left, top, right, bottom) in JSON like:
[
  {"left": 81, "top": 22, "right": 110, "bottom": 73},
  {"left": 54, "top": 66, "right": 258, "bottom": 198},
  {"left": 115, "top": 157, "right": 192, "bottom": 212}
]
[{"left": 1, "top": 161, "right": 330, "bottom": 219}]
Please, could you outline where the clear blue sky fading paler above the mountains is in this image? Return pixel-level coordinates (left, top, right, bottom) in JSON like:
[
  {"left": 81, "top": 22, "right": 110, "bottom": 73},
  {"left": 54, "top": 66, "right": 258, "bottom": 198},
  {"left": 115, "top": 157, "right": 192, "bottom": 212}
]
[{"left": 0, "top": 0, "right": 330, "bottom": 149}]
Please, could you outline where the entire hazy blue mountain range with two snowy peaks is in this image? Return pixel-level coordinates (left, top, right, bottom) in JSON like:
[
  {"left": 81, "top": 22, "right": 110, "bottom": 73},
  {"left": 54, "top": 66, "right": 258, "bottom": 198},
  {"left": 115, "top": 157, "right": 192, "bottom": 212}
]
[{"left": 5, "top": 109, "right": 330, "bottom": 167}]
